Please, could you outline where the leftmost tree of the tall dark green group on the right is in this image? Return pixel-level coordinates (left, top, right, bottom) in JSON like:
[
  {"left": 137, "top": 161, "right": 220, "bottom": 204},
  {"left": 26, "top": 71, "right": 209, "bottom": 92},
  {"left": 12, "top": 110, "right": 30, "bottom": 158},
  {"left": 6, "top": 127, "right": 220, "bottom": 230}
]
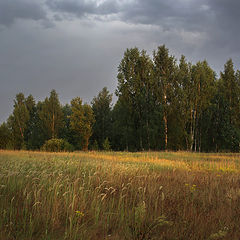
[{"left": 114, "top": 48, "right": 155, "bottom": 150}]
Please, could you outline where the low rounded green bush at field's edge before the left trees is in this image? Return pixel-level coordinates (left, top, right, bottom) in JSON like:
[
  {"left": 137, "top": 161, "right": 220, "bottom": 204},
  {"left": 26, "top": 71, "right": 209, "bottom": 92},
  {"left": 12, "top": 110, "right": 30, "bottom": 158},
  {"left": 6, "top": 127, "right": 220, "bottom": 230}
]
[{"left": 42, "top": 138, "right": 74, "bottom": 152}]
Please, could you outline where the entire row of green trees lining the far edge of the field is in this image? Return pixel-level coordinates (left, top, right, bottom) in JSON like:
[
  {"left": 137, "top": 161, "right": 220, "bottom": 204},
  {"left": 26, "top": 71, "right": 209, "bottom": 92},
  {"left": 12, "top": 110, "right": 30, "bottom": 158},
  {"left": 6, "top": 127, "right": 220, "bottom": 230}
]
[{"left": 0, "top": 45, "right": 240, "bottom": 152}]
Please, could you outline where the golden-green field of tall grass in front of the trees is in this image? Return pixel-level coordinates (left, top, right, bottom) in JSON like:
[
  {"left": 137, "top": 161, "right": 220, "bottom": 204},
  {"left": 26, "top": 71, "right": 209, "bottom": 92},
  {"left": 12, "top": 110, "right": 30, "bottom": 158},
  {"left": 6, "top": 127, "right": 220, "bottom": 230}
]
[{"left": 0, "top": 151, "right": 240, "bottom": 240}]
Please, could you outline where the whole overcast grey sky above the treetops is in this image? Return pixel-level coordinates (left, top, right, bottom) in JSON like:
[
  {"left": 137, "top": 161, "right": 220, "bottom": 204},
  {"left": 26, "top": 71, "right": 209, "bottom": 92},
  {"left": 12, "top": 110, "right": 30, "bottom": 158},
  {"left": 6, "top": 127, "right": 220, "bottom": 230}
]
[{"left": 0, "top": 0, "right": 240, "bottom": 123}]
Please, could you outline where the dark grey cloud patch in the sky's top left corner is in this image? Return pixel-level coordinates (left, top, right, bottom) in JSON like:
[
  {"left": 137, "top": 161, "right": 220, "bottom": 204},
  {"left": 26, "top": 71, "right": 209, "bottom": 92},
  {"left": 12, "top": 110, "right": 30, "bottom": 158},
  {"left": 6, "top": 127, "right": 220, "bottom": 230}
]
[{"left": 0, "top": 0, "right": 46, "bottom": 26}]
